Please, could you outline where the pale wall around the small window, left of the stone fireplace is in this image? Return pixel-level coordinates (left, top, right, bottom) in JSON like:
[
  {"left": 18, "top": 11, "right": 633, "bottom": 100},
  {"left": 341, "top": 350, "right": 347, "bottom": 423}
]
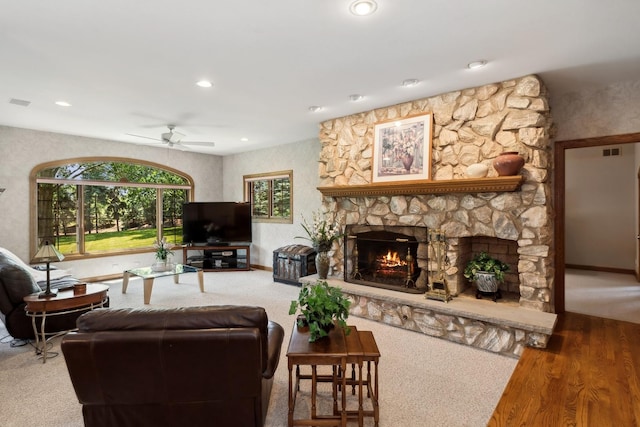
[{"left": 223, "top": 139, "right": 322, "bottom": 267}]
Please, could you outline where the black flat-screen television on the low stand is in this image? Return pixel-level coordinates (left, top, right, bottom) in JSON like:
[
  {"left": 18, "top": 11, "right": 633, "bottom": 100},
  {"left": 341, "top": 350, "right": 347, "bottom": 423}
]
[{"left": 182, "top": 202, "right": 251, "bottom": 246}]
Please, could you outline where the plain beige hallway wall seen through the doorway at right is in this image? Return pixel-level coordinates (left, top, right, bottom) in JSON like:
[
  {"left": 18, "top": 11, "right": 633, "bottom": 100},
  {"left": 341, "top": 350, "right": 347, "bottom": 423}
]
[{"left": 565, "top": 144, "right": 637, "bottom": 270}]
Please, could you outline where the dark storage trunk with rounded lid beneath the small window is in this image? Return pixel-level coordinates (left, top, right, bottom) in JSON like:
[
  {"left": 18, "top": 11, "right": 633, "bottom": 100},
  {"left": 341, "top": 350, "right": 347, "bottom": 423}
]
[{"left": 273, "top": 245, "right": 316, "bottom": 285}]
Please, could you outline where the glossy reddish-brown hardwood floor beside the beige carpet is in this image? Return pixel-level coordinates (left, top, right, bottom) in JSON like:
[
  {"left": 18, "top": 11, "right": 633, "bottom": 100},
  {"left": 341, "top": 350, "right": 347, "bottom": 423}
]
[{"left": 488, "top": 313, "right": 640, "bottom": 427}]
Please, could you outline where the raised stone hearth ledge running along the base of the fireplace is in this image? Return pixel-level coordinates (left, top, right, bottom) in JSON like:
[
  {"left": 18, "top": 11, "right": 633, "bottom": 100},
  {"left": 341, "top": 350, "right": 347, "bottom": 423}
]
[{"left": 300, "top": 275, "right": 557, "bottom": 358}]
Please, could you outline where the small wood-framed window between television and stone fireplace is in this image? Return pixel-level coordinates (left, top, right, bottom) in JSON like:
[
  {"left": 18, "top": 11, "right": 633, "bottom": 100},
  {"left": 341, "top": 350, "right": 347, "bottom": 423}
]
[{"left": 243, "top": 170, "right": 293, "bottom": 224}]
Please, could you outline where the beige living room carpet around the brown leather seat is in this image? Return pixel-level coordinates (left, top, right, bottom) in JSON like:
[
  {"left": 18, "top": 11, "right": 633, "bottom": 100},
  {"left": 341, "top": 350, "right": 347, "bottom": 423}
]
[{"left": 0, "top": 270, "right": 517, "bottom": 427}]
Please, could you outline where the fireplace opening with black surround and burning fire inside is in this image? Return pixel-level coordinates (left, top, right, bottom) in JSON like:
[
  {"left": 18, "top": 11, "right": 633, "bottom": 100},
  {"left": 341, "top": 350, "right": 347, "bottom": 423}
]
[{"left": 344, "top": 225, "right": 428, "bottom": 293}]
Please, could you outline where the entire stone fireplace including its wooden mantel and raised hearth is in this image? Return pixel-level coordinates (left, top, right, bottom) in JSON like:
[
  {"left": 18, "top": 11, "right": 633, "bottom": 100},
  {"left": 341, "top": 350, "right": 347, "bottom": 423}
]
[{"left": 302, "top": 76, "right": 555, "bottom": 354}]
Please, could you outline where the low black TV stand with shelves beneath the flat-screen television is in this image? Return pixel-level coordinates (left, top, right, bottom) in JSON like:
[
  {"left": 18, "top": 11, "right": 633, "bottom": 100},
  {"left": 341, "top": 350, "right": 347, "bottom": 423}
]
[{"left": 182, "top": 244, "right": 251, "bottom": 271}]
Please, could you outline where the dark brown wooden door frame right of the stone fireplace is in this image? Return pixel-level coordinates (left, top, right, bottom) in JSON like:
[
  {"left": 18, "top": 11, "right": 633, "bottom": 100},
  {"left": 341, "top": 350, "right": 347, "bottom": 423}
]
[{"left": 553, "top": 133, "right": 640, "bottom": 313}]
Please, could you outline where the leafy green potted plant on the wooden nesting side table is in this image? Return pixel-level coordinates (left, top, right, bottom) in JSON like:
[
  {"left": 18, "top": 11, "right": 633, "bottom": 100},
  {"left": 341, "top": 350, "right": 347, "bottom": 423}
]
[{"left": 289, "top": 280, "right": 351, "bottom": 342}]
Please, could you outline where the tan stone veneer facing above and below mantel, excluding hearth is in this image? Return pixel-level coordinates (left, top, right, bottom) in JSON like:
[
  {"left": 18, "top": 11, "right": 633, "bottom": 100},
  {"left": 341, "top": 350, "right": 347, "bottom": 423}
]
[{"left": 319, "top": 75, "right": 553, "bottom": 312}]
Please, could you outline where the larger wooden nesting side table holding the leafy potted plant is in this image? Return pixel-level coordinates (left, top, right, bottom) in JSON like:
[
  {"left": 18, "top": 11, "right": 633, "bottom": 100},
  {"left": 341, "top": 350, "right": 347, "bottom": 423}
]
[{"left": 287, "top": 325, "right": 348, "bottom": 427}]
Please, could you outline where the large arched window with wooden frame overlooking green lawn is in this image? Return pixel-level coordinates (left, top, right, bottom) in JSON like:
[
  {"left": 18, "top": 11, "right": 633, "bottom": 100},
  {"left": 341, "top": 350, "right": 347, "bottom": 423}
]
[{"left": 31, "top": 157, "right": 193, "bottom": 258}]
